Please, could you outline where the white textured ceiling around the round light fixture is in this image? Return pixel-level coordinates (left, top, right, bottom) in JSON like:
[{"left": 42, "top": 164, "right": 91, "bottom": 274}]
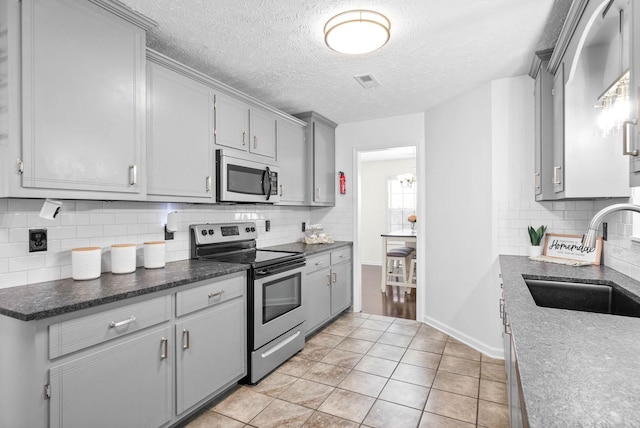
[{"left": 121, "top": 0, "right": 570, "bottom": 123}]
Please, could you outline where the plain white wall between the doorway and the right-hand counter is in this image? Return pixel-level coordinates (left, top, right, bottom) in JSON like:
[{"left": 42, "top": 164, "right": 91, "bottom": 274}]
[{"left": 419, "top": 83, "right": 504, "bottom": 356}]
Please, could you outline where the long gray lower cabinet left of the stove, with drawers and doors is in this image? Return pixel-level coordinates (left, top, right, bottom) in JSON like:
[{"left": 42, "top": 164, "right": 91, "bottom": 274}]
[{"left": 0, "top": 271, "right": 247, "bottom": 428}]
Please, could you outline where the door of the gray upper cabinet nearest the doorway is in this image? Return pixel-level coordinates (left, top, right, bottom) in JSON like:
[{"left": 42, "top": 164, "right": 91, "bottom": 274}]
[{"left": 313, "top": 121, "right": 336, "bottom": 205}]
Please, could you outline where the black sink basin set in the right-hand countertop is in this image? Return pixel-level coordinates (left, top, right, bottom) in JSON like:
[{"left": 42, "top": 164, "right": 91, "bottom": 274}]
[{"left": 524, "top": 278, "right": 640, "bottom": 318}]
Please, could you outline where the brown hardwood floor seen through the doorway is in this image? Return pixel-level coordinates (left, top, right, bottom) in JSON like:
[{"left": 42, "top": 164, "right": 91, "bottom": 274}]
[{"left": 362, "top": 265, "right": 417, "bottom": 320}]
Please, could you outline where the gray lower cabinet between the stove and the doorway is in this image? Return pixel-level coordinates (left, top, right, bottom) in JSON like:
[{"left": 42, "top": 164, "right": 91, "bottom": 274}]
[{"left": 303, "top": 247, "right": 353, "bottom": 335}]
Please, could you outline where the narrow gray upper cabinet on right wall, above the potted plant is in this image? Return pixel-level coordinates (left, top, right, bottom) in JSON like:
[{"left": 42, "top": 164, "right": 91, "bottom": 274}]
[{"left": 533, "top": 50, "right": 555, "bottom": 201}]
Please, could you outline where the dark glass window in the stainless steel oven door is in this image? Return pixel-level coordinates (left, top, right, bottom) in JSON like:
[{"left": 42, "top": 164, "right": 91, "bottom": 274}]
[{"left": 262, "top": 273, "right": 302, "bottom": 324}]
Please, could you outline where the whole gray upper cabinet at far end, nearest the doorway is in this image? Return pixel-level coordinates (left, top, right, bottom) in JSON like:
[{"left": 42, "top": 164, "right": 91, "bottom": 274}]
[{"left": 295, "top": 112, "right": 337, "bottom": 206}]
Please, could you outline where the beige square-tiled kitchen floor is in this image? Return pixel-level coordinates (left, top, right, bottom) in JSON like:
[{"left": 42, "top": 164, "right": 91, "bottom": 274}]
[{"left": 188, "top": 313, "right": 509, "bottom": 428}]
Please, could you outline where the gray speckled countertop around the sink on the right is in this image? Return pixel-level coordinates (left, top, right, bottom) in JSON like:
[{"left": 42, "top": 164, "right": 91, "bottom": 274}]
[{"left": 500, "top": 256, "right": 640, "bottom": 428}]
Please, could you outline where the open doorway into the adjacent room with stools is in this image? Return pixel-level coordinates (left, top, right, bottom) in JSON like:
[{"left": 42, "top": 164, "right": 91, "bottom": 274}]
[{"left": 355, "top": 146, "right": 419, "bottom": 320}]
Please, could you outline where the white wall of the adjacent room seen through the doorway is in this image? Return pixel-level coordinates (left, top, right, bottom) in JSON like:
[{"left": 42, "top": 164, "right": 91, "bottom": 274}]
[{"left": 360, "top": 159, "right": 416, "bottom": 265}]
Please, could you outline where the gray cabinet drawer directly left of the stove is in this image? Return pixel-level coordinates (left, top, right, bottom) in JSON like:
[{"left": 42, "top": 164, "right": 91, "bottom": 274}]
[{"left": 176, "top": 272, "right": 247, "bottom": 316}]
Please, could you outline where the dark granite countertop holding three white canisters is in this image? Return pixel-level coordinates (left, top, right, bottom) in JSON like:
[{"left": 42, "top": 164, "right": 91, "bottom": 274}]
[{"left": 0, "top": 260, "right": 249, "bottom": 321}]
